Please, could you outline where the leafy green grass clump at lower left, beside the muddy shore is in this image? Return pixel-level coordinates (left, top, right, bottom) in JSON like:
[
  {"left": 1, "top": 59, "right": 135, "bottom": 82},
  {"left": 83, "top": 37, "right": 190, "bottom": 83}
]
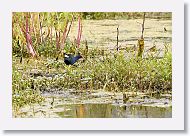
[{"left": 12, "top": 66, "right": 44, "bottom": 113}]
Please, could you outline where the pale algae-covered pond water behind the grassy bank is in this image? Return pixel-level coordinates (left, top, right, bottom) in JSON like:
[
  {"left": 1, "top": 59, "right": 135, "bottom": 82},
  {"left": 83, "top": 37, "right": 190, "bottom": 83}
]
[{"left": 69, "top": 19, "right": 172, "bottom": 49}]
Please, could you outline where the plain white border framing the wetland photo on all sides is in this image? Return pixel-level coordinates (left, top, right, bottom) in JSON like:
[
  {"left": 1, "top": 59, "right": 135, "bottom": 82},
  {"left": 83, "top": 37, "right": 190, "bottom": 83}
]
[{"left": 0, "top": 0, "right": 184, "bottom": 130}]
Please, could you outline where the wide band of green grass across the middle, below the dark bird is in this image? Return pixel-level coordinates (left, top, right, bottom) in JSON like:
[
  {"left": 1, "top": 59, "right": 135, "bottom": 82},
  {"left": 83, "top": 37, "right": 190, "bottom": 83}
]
[{"left": 12, "top": 46, "right": 172, "bottom": 109}]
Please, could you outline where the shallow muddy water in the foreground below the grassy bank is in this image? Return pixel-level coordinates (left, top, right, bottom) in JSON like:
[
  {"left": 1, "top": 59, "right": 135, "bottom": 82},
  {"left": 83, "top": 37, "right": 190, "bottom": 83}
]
[{"left": 16, "top": 91, "right": 172, "bottom": 118}]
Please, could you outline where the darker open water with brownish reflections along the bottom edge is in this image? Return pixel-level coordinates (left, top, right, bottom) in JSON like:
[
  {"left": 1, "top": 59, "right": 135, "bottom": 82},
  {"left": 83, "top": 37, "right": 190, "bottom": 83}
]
[{"left": 56, "top": 104, "right": 172, "bottom": 118}]
